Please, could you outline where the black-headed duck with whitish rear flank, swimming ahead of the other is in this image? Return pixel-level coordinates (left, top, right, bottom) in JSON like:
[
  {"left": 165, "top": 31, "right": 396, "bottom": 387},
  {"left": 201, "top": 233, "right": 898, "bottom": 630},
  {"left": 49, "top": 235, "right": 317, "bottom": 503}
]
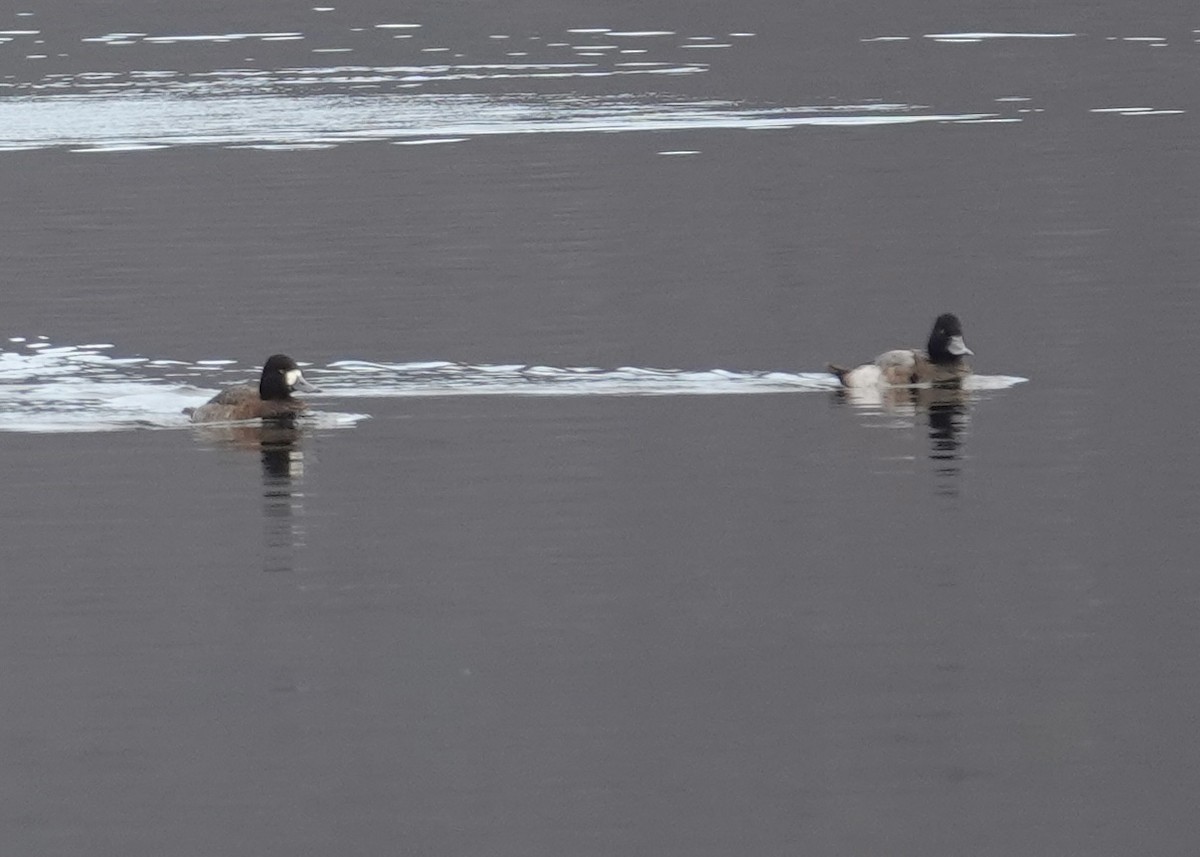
[{"left": 829, "top": 312, "right": 974, "bottom": 388}]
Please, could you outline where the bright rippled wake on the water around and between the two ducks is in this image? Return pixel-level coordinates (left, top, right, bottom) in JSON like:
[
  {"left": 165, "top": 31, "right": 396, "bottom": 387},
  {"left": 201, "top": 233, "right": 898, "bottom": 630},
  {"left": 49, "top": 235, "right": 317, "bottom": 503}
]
[{"left": 0, "top": 337, "right": 1024, "bottom": 433}]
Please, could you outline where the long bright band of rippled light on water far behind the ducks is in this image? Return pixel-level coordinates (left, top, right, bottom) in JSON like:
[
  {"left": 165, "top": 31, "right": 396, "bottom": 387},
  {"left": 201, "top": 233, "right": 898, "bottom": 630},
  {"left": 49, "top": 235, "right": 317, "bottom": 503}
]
[{"left": 0, "top": 92, "right": 1003, "bottom": 151}]
